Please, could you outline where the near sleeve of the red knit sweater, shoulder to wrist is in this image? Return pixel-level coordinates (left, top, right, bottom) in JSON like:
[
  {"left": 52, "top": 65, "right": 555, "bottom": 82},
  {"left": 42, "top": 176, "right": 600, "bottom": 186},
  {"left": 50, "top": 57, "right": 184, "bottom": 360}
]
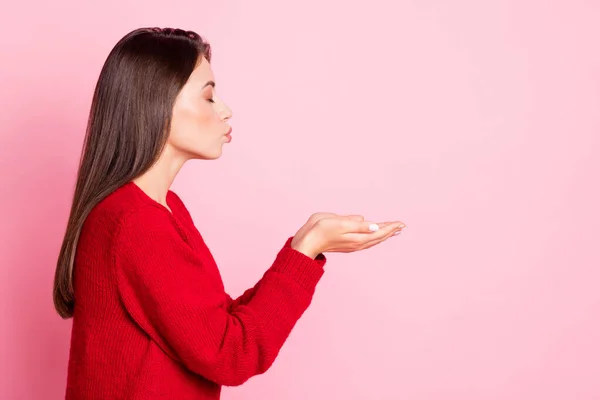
[{"left": 114, "top": 206, "right": 326, "bottom": 386}]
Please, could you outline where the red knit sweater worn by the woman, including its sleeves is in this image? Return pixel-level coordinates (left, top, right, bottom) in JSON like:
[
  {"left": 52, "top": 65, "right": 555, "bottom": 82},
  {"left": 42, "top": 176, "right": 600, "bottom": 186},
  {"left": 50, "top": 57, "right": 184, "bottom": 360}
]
[{"left": 66, "top": 182, "right": 326, "bottom": 400}]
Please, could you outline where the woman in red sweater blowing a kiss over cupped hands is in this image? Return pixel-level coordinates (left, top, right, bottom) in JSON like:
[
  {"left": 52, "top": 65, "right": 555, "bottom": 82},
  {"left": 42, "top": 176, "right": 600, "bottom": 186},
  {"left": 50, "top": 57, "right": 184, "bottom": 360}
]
[{"left": 54, "top": 28, "right": 404, "bottom": 400}]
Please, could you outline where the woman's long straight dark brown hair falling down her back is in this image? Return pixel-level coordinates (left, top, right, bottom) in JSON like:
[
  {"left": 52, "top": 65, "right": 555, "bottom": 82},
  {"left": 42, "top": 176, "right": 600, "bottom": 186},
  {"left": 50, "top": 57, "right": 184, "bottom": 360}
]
[{"left": 54, "top": 28, "right": 211, "bottom": 319}]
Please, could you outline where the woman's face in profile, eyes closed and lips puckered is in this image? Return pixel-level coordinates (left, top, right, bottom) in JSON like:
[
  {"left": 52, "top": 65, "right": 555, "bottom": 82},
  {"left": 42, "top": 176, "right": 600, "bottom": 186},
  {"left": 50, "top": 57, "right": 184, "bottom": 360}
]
[{"left": 167, "top": 57, "right": 232, "bottom": 160}]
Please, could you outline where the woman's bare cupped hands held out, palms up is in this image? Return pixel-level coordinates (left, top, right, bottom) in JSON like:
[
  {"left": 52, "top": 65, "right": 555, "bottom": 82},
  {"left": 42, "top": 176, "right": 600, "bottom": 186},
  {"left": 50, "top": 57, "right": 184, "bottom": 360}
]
[{"left": 292, "top": 214, "right": 406, "bottom": 258}]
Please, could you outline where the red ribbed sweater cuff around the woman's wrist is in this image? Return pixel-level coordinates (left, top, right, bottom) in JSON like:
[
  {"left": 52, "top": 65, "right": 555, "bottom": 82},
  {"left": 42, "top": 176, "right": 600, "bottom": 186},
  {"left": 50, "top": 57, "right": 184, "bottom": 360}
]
[{"left": 273, "top": 237, "right": 327, "bottom": 292}]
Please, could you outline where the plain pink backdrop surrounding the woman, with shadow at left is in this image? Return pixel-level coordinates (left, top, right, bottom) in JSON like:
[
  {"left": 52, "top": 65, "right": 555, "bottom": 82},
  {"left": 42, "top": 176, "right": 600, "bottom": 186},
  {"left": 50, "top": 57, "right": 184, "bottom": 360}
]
[{"left": 0, "top": 0, "right": 600, "bottom": 400}]
